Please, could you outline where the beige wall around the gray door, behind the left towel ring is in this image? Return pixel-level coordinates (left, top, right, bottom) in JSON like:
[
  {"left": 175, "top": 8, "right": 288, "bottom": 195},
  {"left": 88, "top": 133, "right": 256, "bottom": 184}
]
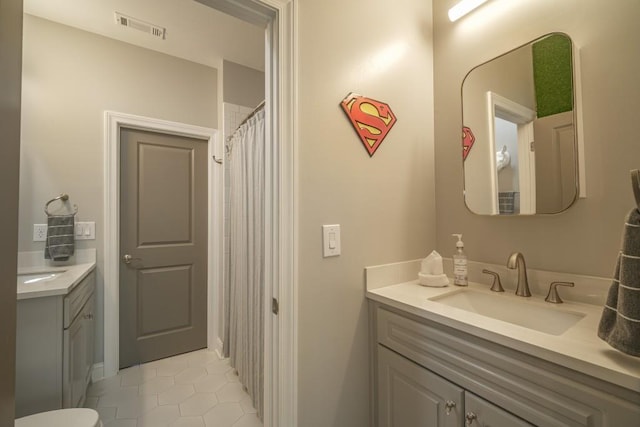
[{"left": 19, "top": 15, "right": 217, "bottom": 361}]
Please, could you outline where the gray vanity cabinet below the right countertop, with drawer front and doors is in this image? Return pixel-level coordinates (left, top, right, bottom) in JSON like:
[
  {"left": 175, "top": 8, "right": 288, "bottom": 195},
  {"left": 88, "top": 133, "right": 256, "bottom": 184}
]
[{"left": 369, "top": 301, "right": 640, "bottom": 427}]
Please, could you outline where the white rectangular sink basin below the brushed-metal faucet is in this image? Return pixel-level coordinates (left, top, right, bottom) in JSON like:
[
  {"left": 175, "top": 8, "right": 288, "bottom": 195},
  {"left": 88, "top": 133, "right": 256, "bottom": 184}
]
[{"left": 429, "top": 289, "right": 585, "bottom": 335}]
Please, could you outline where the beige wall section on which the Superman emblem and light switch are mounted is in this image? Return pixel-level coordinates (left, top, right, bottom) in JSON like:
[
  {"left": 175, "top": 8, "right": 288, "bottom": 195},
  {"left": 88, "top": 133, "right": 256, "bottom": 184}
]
[{"left": 298, "top": 0, "right": 435, "bottom": 427}]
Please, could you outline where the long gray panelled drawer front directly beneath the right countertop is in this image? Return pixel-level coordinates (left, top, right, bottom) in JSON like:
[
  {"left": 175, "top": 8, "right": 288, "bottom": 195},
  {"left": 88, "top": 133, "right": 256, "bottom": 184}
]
[{"left": 375, "top": 305, "right": 640, "bottom": 427}]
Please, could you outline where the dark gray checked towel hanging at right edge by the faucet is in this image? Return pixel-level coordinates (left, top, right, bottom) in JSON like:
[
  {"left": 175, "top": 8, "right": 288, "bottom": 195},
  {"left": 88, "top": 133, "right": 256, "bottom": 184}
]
[{"left": 598, "top": 209, "right": 640, "bottom": 356}]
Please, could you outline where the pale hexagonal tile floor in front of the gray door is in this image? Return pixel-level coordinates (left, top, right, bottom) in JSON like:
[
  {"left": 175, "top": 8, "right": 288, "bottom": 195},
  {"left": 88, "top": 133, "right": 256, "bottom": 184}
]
[{"left": 85, "top": 350, "right": 262, "bottom": 427}]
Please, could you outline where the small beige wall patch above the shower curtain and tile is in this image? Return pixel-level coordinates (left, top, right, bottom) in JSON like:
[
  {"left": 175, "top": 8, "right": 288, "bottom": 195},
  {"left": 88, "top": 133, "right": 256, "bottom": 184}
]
[{"left": 222, "top": 61, "right": 265, "bottom": 107}]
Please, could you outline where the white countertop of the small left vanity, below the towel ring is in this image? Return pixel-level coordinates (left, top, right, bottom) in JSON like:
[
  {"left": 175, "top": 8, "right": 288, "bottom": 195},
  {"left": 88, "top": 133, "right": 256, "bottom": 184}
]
[{"left": 17, "top": 249, "right": 96, "bottom": 300}]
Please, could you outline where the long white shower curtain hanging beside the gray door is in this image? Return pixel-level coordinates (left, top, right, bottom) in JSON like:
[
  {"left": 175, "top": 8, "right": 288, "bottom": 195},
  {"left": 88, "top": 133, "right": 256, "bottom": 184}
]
[{"left": 225, "top": 109, "right": 265, "bottom": 418}]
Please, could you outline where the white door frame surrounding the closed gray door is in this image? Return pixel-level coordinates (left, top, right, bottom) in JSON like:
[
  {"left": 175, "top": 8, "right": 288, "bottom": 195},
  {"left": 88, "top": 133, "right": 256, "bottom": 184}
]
[{"left": 104, "top": 111, "right": 224, "bottom": 377}]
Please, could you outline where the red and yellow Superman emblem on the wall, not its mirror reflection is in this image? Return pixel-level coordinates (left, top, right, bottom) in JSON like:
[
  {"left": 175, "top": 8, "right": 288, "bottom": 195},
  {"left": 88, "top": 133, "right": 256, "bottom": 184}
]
[{"left": 340, "top": 93, "right": 396, "bottom": 157}]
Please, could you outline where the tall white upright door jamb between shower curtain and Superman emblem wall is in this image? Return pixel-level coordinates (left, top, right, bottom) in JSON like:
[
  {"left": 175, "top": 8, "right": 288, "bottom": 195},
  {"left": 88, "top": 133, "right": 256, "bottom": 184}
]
[{"left": 256, "top": 0, "right": 298, "bottom": 427}]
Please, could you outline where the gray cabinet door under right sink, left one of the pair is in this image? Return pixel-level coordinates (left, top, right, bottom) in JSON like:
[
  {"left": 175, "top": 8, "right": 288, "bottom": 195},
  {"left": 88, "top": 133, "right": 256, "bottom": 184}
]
[{"left": 378, "top": 345, "right": 464, "bottom": 427}]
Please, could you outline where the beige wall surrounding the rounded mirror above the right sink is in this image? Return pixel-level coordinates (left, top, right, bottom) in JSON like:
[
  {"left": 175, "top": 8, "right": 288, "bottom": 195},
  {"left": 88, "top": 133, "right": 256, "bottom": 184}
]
[{"left": 434, "top": 0, "right": 640, "bottom": 278}]
